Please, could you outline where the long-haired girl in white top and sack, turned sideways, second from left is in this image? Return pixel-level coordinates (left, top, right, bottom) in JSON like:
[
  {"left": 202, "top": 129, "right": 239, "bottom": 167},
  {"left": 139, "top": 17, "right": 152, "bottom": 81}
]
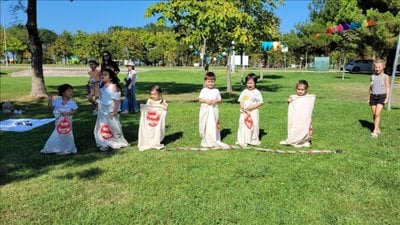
[{"left": 94, "top": 68, "right": 128, "bottom": 151}]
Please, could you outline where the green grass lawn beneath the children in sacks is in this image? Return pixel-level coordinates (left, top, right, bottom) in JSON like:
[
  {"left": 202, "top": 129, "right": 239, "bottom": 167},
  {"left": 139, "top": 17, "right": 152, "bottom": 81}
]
[{"left": 0, "top": 67, "right": 400, "bottom": 224}]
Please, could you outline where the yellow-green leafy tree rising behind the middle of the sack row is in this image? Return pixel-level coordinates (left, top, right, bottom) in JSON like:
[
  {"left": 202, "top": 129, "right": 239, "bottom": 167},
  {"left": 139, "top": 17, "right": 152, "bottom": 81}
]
[{"left": 145, "top": 0, "right": 282, "bottom": 92}]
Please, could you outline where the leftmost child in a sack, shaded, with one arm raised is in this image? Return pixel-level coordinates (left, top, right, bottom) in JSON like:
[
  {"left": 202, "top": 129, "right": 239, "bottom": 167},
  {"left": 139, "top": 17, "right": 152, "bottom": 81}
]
[{"left": 40, "top": 84, "right": 78, "bottom": 155}]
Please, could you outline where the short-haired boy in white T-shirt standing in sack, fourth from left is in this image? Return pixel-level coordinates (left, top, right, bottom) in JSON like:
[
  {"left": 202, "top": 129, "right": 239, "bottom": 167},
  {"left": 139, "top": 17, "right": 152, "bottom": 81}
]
[{"left": 199, "top": 72, "right": 227, "bottom": 148}]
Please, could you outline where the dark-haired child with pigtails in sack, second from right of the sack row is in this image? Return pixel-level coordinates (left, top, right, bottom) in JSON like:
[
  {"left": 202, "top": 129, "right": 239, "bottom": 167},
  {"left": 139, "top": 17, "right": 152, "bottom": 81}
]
[{"left": 236, "top": 73, "right": 263, "bottom": 147}]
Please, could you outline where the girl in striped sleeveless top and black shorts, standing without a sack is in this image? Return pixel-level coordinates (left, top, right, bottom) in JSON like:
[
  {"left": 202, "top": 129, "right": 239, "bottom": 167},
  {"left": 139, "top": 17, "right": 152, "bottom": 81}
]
[{"left": 368, "top": 59, "right": 390, "bottom": 138}]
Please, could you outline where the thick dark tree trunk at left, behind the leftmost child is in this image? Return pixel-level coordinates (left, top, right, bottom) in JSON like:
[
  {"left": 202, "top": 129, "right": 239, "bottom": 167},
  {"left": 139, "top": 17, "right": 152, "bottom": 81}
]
[{"left": 26, "top": 0, "right": 47, "bottom": 97}]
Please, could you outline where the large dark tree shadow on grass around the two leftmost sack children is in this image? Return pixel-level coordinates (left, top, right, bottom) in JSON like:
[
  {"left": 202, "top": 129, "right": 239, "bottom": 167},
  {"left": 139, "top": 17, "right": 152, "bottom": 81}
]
[{"left": 0, "top": 102, "right": 137, "bottom": 186}]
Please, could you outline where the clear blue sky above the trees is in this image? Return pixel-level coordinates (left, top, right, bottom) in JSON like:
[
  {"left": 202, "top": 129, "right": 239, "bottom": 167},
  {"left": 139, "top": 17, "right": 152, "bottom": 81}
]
[{"left": 0, "top": 0, "right": 311, "bottom": 34}]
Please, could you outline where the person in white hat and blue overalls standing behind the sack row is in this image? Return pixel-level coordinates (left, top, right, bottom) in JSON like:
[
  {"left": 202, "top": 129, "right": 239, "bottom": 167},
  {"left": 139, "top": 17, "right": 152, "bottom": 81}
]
[{"left": 122, "top": 61, "right": 139, "bottom": 114}]
